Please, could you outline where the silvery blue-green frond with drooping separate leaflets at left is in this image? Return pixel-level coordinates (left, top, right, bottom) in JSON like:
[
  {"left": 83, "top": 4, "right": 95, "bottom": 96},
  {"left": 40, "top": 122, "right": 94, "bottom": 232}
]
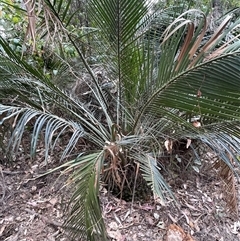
[{"left": 0, "top": 105, "right": 85, "bottom": 160}]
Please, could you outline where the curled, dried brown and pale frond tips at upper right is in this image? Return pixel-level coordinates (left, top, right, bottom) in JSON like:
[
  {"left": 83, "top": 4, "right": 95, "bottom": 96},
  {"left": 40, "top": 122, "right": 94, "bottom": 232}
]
[{"left": 161, "top": 9, "right": 234, "bottom": 71}]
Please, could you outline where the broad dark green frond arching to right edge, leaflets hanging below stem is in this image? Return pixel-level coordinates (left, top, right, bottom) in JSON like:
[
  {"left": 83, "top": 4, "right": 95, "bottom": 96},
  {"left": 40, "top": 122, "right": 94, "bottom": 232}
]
[{"left": 142, "top": 52, "right": 240, "bottom": 125}]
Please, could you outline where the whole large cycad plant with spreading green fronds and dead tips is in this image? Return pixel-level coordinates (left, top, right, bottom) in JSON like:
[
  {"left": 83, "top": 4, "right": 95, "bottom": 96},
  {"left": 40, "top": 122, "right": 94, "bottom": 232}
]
[{"left": 0, "top": 0, "right": 240, "bottom": 240}]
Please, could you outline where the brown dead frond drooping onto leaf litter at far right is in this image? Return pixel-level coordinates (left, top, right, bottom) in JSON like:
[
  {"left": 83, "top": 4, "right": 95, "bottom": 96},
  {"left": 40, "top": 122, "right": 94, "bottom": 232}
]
[{"left": 214, "top": 156, "right": 238, "bottom": 217}]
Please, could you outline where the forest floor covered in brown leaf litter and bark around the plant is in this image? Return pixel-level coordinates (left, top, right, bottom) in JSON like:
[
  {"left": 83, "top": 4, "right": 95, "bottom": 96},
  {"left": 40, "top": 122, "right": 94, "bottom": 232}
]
[{"left": 0, "top": 146, "right": 240, "bottom": 241}]
